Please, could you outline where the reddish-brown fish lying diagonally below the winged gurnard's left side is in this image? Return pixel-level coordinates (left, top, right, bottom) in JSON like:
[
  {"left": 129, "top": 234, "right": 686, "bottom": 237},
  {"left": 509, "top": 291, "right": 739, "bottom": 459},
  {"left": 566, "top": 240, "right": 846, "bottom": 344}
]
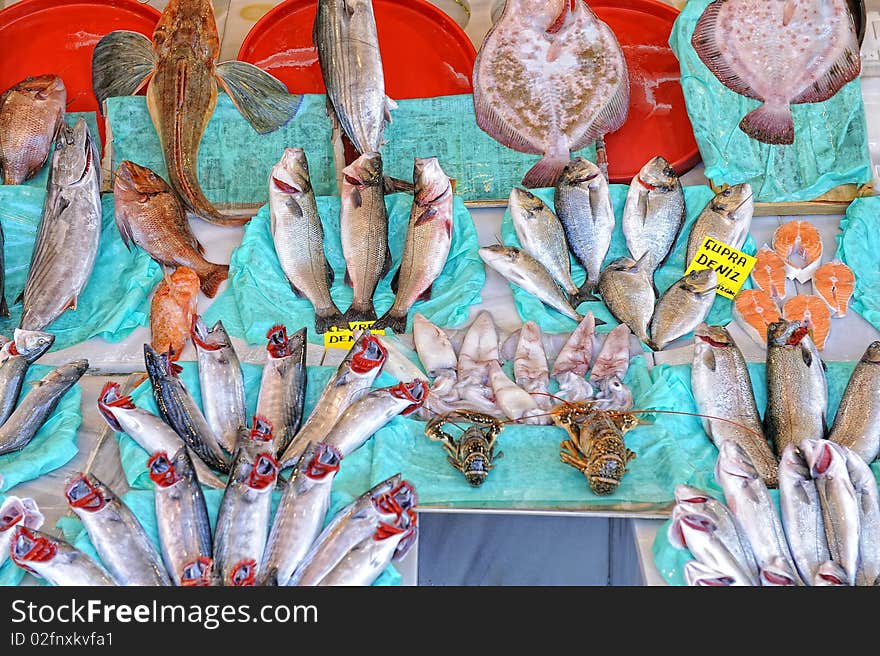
[{"left": 113, "top": 160, "right": 229, "bottom": 298}]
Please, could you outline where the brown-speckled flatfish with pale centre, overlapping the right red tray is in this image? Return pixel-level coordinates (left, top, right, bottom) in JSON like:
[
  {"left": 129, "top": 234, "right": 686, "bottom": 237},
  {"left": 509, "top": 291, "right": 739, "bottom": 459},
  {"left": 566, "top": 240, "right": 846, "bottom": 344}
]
[{"left": 473, "top": 0, "right": 629, "bottom": 188}]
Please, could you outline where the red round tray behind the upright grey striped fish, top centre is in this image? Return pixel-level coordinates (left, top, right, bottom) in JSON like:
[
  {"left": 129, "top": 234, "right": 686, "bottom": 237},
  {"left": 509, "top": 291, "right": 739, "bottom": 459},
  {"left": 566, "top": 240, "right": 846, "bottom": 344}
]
[{"left": 238, "top": 0, "right": 476, "bottom": 100}]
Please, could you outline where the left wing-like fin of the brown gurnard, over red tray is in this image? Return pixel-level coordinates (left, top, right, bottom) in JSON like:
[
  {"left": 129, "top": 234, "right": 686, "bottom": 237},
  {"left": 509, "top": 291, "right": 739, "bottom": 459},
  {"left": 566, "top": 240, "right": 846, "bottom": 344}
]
[{"left": 92, "top": 30, "right": 156, "bottom": 114}]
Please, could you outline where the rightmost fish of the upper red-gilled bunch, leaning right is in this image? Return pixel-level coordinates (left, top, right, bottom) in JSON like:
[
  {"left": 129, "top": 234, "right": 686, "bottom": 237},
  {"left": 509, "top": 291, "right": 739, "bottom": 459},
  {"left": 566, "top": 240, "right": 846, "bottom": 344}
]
[{"left": 323, "top": 380, "right": 428, "bottom": 458}]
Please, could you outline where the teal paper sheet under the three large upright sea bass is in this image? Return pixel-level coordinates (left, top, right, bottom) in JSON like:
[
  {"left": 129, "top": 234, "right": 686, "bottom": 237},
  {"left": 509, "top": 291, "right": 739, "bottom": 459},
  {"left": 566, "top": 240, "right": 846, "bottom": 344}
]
[{"left": 205, "top": 194, "right": 486, "bottom": 344}]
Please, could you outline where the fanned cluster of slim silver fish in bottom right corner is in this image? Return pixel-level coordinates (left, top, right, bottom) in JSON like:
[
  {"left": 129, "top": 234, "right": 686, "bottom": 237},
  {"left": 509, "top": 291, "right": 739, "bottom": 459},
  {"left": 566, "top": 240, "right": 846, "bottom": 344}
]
[{"left": 668, "top": 439, "right": 880, "bottom": 586}]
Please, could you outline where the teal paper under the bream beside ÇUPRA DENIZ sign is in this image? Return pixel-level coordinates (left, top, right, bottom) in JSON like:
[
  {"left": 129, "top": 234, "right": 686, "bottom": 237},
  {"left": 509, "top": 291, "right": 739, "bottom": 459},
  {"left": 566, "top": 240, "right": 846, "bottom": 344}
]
[{"left": 498, "top": 184, "right": 756, "bottom": 332}]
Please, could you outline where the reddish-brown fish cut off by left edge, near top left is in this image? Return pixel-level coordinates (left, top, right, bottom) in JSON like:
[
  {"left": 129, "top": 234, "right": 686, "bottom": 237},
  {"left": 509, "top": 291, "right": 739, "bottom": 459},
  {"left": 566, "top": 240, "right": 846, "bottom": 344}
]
[{"left": 0, "top": 75, "right": 67, "bottom": 186}]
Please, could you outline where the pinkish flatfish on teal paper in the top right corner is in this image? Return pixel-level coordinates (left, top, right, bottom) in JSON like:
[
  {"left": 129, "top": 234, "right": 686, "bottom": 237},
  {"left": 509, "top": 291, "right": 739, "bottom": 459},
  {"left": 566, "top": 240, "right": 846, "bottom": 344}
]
[{"left": 691, "top": 0, "right": 861, "bottom": 144}]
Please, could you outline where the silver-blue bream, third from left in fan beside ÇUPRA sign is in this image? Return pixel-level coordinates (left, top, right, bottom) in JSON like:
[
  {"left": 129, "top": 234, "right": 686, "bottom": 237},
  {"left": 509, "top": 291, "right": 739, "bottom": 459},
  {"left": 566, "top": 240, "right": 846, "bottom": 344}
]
[{"left": 555, "top": 157, "right": 617, "bottom": 289}]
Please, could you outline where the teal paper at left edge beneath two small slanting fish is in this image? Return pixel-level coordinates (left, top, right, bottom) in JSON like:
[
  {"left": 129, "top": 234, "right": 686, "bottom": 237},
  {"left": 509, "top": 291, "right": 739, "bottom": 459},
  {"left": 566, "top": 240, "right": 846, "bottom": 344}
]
[{"left": 0, "top": 364, "right": 82, "bottom": 491}]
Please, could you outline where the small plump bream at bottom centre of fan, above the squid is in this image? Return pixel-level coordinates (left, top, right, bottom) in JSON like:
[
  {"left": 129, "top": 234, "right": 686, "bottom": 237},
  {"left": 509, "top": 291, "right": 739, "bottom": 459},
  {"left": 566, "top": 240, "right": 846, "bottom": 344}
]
[{"left": 599, "top": 253, "right": 657, "bottom": 343}]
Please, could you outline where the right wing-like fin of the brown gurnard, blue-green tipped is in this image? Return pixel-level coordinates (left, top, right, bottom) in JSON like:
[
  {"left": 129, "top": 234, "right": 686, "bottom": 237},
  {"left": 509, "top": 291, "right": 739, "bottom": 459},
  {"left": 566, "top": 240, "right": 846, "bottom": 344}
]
[{"left": 215, "top": 61, "right": 302, "bottom": 134}]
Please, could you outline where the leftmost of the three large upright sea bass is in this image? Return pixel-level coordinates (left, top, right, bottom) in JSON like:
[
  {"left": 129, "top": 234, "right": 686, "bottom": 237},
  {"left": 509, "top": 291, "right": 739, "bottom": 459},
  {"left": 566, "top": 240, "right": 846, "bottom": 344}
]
[{"left": 269, "top": 148, "right": 348, "bottom": 334}]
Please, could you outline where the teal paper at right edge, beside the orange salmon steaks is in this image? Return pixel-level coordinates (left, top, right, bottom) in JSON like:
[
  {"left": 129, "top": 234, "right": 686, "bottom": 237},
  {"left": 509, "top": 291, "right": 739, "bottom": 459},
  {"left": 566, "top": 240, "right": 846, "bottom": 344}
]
[{"left": 837, "top": 196, "right": 880, "bottom": 330}]
